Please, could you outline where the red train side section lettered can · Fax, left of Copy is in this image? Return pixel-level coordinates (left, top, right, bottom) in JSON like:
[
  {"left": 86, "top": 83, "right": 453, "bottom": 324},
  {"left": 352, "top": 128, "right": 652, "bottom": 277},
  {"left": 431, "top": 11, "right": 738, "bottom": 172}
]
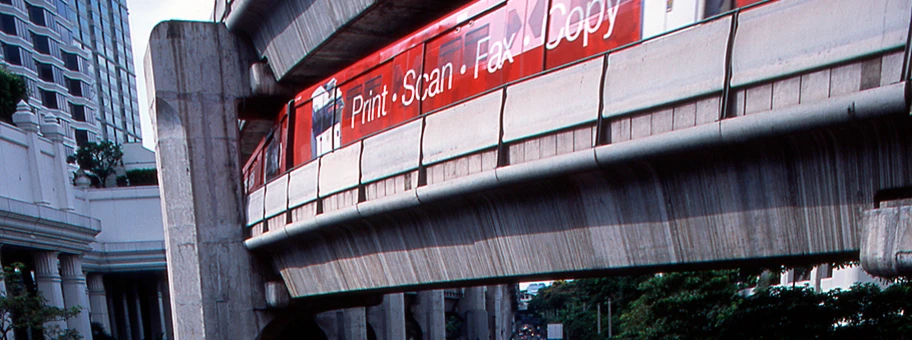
[{"left": 422, "top": 0, "right": 548, "bottom": 113}]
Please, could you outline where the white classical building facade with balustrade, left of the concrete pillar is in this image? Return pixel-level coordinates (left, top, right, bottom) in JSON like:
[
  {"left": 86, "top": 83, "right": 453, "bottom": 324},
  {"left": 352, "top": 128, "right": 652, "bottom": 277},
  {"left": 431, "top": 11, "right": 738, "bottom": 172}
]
[{"left": 0, "top": 104, "right": 171, "bottom": 340}]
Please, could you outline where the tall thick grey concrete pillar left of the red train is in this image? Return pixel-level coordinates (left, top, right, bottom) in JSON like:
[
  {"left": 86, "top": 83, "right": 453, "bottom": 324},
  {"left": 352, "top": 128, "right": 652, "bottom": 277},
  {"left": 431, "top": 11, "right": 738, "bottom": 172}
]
[{"left": 145, "top": 21, "right": 269, "bottom": 340}]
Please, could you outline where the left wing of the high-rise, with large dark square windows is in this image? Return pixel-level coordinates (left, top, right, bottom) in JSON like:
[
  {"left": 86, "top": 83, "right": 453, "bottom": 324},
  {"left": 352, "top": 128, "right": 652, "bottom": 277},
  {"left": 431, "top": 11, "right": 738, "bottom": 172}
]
[{"left": 0, "top": 0, "right": 101, "bottom": 144}]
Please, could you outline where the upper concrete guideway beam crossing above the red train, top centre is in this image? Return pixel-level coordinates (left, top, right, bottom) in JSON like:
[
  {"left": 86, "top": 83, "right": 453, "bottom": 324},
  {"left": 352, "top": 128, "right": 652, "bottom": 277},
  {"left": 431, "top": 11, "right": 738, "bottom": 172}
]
[{"left": 222, "top": 0, "right": 469, "bottom": 83}]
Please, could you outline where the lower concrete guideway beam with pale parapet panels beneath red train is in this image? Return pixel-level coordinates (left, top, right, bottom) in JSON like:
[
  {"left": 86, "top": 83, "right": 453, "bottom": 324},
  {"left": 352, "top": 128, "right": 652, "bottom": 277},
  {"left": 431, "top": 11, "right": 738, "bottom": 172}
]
[{"left": 245, "top": 0, "right": 912, "bottom": 297}]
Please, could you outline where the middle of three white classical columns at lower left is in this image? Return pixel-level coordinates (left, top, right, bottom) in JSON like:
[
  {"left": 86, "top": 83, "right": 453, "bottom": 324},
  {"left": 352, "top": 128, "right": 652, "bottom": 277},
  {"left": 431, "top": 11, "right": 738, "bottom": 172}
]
[{"left": 60, "top": 255, "right": 92, "bottom": 339}]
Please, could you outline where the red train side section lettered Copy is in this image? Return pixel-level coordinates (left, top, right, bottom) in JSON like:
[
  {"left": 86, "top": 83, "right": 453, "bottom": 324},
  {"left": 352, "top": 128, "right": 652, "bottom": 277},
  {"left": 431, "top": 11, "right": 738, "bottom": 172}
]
[{"left": 545, "top": 0, "right": 641, "bottom": 69}]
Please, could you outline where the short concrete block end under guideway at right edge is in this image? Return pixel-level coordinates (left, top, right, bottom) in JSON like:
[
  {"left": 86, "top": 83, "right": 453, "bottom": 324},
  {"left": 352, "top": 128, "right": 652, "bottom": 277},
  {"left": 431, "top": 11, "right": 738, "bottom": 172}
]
[{"left": 861, "top": 205, "right": 912, "bottom": 277}]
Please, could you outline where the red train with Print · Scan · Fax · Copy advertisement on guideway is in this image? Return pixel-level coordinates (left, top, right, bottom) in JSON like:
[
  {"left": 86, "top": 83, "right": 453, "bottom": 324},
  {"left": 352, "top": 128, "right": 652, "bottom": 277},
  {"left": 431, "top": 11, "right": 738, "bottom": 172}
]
[{"left": 243, "top": 0, "right": 775, "bottom": 197}]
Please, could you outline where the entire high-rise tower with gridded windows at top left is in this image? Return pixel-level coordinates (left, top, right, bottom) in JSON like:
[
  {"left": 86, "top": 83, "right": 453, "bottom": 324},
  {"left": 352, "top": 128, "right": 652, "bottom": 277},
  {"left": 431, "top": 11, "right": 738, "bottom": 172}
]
[{"left": 0, "top": 0, "right": 142, "bottom": 145}]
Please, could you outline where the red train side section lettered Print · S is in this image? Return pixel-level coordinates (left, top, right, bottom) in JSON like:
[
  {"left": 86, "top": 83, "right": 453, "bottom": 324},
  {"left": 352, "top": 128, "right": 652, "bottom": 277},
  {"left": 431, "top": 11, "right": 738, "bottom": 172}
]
[{"left": 336, "top": 45, "right": 423, "bottom": 147}]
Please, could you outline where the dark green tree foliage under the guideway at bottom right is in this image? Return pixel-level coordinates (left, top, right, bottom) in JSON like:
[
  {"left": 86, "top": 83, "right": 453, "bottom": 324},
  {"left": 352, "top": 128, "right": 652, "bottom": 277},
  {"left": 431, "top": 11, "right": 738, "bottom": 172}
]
[{"left": 529, "top": 270, "right": 912, "bottom": 340}]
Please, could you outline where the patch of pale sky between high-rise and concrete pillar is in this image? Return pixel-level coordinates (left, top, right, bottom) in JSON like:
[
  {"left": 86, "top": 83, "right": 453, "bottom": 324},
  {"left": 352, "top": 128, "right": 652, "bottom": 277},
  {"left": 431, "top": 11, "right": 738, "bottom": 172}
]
[{"left": 127, "top": 0, "right": 214, "bottom": 150}]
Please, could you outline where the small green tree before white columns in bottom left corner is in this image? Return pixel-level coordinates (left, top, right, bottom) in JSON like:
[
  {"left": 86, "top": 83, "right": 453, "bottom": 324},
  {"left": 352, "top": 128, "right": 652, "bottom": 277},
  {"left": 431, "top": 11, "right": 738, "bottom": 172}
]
[{"left": 0, "top": 263, "right": 82, "bottom": 340}]
